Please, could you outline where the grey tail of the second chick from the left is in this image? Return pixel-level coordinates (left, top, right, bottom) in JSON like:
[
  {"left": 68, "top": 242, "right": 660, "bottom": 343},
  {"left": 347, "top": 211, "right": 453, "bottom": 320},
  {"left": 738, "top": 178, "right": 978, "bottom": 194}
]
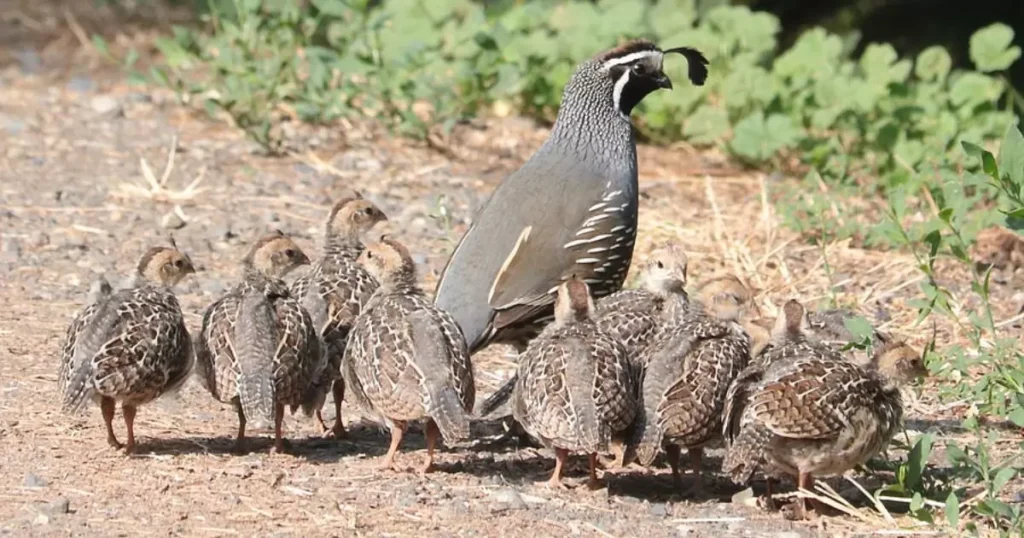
[{"left": 233, "top": 292, "right": 278, "bottom": 422}]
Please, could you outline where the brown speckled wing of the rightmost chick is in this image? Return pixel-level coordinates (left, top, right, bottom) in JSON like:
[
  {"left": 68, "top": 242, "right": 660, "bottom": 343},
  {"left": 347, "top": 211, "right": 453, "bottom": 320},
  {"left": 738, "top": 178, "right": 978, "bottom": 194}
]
[{"left": 748, "top": 358, "right": 870, "bottom": 439}]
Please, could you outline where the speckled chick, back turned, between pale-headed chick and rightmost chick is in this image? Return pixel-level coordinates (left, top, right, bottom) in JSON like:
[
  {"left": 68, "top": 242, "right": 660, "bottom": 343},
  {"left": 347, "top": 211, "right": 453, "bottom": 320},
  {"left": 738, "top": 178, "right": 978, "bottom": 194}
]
[{"left": 630, "top": 261, "right": 751, "bottom": 494}]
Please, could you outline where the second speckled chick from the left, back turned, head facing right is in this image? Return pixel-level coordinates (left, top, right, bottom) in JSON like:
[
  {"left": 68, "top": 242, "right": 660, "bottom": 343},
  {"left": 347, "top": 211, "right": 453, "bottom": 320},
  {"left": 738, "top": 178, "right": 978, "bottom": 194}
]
[{"left": 196, "top": 232, "right": 319, "bottom": 453}]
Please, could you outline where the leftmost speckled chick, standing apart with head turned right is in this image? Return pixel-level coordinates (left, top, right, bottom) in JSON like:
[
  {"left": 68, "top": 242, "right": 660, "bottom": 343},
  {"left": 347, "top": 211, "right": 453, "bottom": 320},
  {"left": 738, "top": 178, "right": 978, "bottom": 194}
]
[{"left": 57, "top": 247, "right": 196, "bottom": 453}]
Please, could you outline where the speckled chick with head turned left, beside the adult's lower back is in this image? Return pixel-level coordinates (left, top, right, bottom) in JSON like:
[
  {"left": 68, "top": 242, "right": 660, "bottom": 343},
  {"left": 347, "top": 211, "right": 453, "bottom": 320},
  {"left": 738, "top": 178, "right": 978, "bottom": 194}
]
[{"left": 342, "top": 237, "right": 476, "bottom": 472}]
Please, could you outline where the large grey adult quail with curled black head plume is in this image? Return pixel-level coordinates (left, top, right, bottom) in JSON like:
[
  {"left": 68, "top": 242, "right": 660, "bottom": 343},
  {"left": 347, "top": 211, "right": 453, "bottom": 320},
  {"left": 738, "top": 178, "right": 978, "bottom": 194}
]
[{"left": 435, "top": 40, "right": 708, "bottom": 350}]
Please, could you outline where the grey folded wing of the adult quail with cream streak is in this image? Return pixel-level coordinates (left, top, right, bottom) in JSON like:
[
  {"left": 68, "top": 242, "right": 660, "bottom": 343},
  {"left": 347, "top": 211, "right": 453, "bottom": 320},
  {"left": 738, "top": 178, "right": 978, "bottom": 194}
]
[{"left": 435, "top": 146, "right": 636, "bottom": 348}]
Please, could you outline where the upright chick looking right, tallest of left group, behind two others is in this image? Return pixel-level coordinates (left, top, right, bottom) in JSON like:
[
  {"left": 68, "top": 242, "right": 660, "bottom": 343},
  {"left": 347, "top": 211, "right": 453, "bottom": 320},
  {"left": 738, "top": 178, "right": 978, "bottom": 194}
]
[{"left": 291, "top": 193, "right": 387, "bottom": 439}]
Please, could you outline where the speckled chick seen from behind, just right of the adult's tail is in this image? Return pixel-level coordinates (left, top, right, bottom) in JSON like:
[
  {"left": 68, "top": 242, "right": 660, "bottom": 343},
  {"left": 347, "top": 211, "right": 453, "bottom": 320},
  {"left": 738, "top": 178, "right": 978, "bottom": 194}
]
[{"left": 512, "top": 278, "right": 637, "bottom": 488}]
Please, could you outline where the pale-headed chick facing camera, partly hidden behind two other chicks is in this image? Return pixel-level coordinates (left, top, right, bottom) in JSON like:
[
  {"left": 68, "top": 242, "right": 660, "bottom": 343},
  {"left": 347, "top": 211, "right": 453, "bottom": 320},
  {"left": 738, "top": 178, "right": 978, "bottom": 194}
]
[{"left": 478, "top": 244, "right": 686, "bottom": 416}]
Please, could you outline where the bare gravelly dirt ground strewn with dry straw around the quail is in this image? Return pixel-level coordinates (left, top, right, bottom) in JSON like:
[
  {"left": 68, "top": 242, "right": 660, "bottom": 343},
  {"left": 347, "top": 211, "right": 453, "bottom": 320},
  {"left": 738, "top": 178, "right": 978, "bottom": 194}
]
[{"left": 0, "top": 1, "right": 1021, "bottom": 537}]
